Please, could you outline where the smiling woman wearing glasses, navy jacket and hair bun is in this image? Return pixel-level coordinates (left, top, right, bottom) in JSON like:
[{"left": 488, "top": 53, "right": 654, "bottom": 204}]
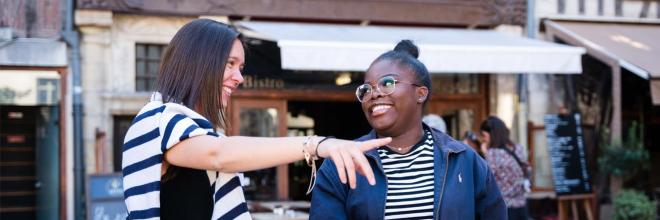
[{"left": 310, "top": 40, "right": 506, "bottom": 219}]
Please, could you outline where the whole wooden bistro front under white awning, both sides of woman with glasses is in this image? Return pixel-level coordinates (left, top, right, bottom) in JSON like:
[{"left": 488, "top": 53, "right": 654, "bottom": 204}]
[{"left": 227, "top": 73, "right": 488, "bottom": 201}]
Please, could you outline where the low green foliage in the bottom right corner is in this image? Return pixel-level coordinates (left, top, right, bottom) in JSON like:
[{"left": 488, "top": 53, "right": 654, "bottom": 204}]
[{"left": 614, "top": 190, "right": 656, "bottom": 220}]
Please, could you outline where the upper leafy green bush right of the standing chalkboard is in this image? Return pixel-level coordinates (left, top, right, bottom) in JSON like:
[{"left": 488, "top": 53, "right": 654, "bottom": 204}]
[{"left": 598, "top": 122, "right": 650, "bottom": 179}]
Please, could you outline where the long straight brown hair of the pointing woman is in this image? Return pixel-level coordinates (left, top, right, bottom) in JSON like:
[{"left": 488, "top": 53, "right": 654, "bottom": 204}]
[{"left": 156, "top": 19, "right": 241, "bottom": 129}]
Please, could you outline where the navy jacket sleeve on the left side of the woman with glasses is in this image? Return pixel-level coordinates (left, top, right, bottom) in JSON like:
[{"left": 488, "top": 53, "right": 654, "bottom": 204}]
[{"left": 309, "top": 159, "right": 348, "bottom": 220}]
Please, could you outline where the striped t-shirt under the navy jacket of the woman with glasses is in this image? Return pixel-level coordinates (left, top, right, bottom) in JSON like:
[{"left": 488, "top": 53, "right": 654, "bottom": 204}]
[{"left": 378, "top": 130, "right": 434, "bottom": 219}]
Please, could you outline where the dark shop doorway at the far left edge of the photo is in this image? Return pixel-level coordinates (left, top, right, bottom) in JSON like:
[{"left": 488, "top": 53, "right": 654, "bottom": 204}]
[{"left": 0, "top": 105, "right": 60, "bottom": 219}]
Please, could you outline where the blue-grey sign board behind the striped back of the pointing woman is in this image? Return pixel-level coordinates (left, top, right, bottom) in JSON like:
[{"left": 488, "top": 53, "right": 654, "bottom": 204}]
[{"left": 87, "top": 173, "right": 128, "bottom": 220}]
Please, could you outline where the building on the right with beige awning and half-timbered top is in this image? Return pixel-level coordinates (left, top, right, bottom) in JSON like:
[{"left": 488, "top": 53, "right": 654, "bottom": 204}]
[{"left": 528, "top": 0, "right": 660, "bottom": 217}]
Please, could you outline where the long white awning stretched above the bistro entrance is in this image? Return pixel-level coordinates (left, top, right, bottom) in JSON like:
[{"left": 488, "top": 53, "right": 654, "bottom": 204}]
[{"left": 237, "top": 22, "right": 585, "bottom": 74}]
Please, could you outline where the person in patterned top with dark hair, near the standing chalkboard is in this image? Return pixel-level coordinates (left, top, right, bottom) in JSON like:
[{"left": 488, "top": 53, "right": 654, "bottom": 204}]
[{"left": 480, "top": 116, "right": 530, "bottom": 220}]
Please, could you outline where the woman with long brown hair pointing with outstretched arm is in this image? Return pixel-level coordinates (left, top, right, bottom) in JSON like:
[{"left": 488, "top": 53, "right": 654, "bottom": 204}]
[{"left": 122, "top": 19, "right": 390, "bottom": 220}]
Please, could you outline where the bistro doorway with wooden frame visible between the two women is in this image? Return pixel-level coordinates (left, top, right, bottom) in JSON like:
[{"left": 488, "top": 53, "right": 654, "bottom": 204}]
[{"left": 229, "top": 98, "right": 370, "bottom": 201}]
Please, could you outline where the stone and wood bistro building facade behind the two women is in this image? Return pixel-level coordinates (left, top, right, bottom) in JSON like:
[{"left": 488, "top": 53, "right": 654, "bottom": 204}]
[{"left": 76, "top": 0, "right": 540, "bottom": 204}]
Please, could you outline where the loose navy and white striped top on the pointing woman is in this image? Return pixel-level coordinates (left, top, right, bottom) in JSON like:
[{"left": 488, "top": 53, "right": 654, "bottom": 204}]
[{"left": 122, "top": 93, "right": 251, "bottom": 219}]
